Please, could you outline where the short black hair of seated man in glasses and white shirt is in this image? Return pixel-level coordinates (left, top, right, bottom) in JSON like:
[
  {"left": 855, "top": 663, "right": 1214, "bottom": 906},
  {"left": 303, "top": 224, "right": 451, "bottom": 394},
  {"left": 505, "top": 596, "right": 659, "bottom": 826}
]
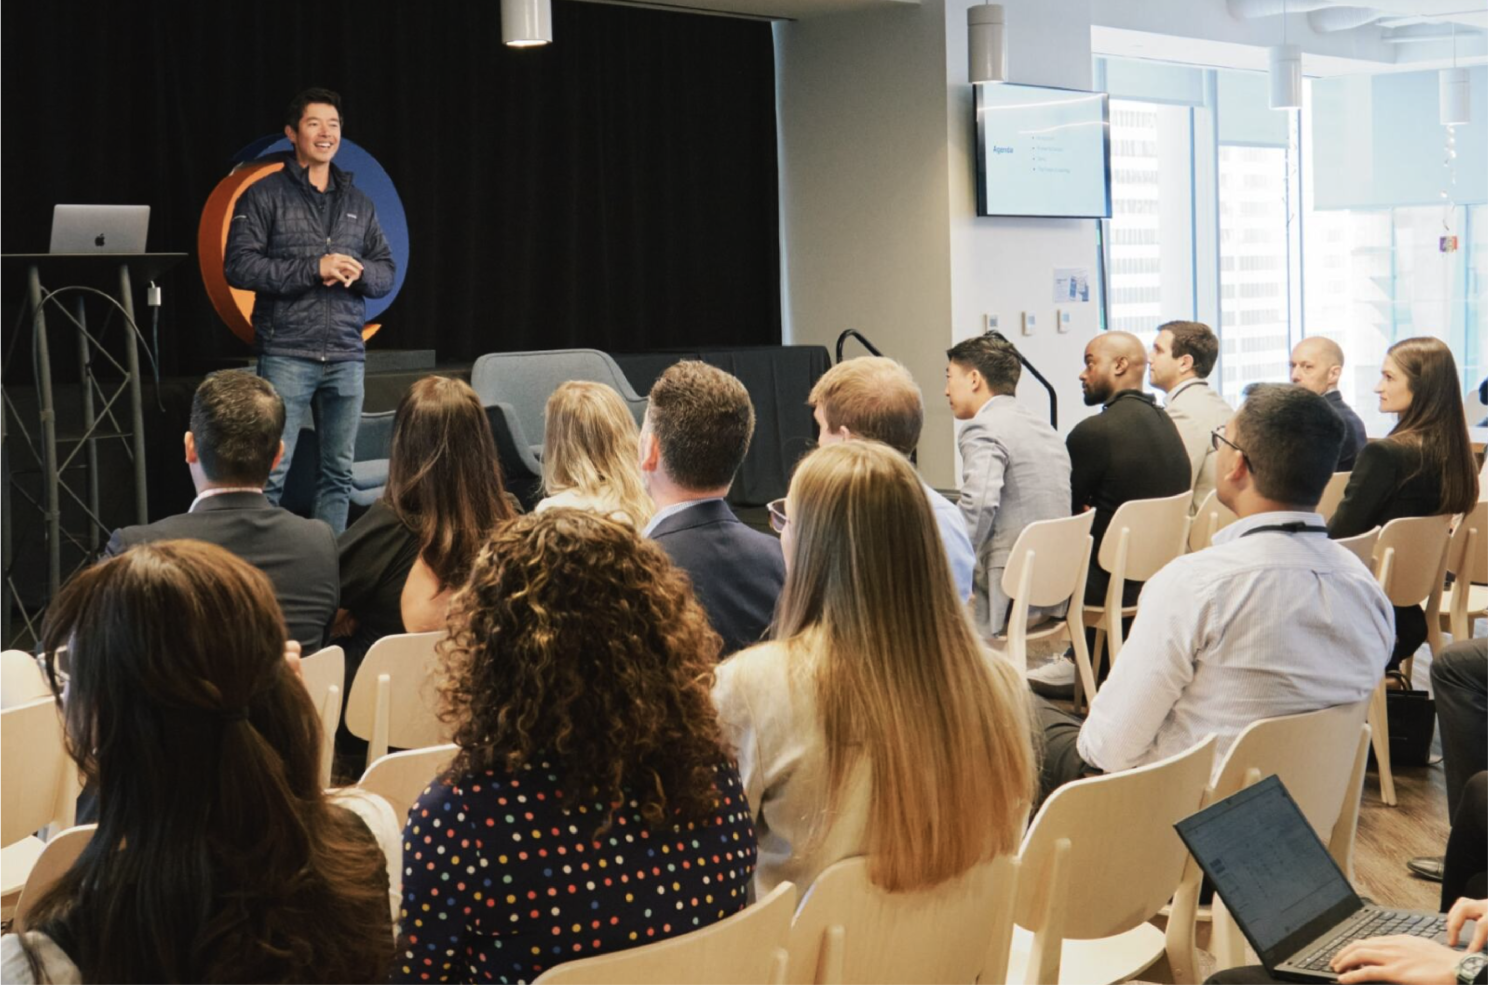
[{"left": 1229, "top": 382, "right": 1344, "bottom": 506}]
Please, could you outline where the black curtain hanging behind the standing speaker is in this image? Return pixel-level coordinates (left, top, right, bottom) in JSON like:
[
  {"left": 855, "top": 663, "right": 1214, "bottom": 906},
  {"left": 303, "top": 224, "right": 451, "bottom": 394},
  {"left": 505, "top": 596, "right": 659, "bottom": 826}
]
[{"left": 0, "top": 0, "right": 780, "bottom": 382}]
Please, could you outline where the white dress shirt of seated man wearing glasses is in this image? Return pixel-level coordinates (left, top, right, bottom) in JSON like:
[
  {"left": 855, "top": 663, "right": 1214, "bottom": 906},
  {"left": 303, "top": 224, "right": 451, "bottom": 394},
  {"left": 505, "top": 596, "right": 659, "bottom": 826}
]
[{"left": 1079, "top": 512, "right": 1394, "bottom": 772}]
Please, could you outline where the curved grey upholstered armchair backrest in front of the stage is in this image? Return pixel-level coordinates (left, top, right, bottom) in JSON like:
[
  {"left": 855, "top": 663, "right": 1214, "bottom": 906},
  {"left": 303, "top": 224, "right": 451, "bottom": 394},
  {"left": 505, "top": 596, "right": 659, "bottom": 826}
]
[{"left": 470, "top": 348, "right": 646, "bottom": 458}]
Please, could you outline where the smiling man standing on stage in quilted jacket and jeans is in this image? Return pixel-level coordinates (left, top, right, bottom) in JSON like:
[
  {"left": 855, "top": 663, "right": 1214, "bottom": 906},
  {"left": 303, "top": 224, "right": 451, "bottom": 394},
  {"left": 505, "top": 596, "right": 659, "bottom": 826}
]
[{"left": 223, "top": 89, "right": 394, "bottom": 534}]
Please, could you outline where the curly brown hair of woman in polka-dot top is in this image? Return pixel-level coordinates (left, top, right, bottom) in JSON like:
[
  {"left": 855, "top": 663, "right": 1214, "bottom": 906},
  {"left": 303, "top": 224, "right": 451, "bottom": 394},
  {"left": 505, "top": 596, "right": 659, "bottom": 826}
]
[{"left": 440, "top": 509, "right": 728, "bottom": 835}]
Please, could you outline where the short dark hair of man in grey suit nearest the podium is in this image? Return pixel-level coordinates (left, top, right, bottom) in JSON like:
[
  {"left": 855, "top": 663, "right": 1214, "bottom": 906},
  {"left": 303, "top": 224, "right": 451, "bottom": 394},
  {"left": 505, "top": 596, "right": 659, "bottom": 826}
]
[{"left": 190, "top": 369, "right": 284, "bottom": 485}]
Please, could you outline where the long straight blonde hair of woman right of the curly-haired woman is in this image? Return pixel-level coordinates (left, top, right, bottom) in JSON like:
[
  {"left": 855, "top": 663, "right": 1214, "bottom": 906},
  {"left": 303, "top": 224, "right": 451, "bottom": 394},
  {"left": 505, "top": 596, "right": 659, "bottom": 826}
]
[{"left": 775, "top": 440, "right": 1036, "bottom": 891}]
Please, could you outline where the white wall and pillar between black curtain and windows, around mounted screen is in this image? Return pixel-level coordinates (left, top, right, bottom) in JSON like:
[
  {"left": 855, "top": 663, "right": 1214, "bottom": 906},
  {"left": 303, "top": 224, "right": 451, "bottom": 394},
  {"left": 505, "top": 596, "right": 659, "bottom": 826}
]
[{"left": 775, "top": 0, "right": 1097, "bottom": 488}]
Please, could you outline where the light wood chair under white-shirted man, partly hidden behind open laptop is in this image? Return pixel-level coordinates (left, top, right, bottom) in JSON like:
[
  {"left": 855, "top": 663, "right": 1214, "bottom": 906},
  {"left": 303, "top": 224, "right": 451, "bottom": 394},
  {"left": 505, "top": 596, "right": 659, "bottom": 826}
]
[{"left": 1167, "top": 698, "right": 1369, "bottom": 985}]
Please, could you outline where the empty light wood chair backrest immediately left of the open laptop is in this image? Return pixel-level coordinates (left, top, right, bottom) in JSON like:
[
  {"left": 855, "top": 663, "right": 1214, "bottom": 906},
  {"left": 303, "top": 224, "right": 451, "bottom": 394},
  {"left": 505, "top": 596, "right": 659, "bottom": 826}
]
[{"left": 1016, "top": 735, "right": 1214, "bottom": 940}]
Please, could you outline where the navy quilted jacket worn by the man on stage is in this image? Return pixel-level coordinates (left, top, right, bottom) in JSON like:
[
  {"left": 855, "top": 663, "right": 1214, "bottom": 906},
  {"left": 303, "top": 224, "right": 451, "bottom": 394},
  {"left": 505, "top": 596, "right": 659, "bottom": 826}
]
[{"left": 223, "top": 155, "right": 396, "bottom": 363}]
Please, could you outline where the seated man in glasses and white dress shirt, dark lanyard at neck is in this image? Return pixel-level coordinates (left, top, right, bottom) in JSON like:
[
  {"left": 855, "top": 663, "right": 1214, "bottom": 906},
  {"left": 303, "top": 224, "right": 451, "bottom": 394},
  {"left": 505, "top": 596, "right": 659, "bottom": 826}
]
[{"left": 1039, "top": 384, "right": 1391, "bottom": 796}]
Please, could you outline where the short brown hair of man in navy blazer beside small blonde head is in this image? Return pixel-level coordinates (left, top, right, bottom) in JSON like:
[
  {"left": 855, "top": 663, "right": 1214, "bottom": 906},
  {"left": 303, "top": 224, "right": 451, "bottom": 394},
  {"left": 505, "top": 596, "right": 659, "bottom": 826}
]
[{"left": 647, "top": 359, "right": 754, "bottom": 490}]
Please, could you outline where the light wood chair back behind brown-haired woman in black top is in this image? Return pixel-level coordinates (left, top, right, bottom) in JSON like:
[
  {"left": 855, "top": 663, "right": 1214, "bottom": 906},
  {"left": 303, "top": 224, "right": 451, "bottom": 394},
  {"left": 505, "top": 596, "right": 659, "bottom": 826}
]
[{"left": 347, "top": 632, "right": 445, "bottom": 766}]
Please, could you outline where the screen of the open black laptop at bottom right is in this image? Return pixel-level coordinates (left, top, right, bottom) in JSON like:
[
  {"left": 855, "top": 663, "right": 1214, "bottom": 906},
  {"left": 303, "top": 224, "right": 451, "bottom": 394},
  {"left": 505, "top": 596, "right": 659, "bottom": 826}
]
[{"left": 1176, "top": 775, "right": 1363, "bottom": 969}]
